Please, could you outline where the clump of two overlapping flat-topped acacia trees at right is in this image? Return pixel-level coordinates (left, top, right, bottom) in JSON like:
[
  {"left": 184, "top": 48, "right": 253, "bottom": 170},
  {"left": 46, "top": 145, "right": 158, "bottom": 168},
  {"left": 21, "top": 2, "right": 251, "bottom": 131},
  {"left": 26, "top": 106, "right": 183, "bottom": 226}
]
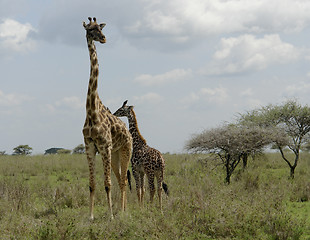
[{"left": 185, "top": 100, "right": 310, "bottom": 183}]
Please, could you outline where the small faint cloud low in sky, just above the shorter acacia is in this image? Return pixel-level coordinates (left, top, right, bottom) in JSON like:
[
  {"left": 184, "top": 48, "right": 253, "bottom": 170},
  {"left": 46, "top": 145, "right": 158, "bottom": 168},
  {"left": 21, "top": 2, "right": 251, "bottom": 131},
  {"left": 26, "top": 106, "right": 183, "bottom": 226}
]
[{"left": 181, "top": 87, "right": 229, "bottom": 105}]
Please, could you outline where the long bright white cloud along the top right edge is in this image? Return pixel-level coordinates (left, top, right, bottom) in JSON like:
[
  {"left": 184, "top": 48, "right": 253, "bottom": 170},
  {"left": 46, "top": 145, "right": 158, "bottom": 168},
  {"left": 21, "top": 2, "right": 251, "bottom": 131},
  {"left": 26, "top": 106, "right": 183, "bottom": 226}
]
[{"left": 125, "top": 0, "right": 310, "bottom": 39}]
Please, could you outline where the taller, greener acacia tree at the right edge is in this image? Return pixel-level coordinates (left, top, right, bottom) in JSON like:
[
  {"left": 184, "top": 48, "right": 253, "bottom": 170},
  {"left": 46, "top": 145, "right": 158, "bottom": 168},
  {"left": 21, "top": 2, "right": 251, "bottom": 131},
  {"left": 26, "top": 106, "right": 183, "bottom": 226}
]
[{"left": 239, "top": 100, "right": 310, "bottom": 178}]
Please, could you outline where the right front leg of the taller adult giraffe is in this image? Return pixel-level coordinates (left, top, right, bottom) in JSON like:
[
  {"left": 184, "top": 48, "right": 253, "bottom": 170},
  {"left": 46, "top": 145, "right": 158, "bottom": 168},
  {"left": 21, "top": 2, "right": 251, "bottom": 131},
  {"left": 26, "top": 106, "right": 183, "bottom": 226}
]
[{"left": 98, "top": 143, "right": 113, "bottom": 218}]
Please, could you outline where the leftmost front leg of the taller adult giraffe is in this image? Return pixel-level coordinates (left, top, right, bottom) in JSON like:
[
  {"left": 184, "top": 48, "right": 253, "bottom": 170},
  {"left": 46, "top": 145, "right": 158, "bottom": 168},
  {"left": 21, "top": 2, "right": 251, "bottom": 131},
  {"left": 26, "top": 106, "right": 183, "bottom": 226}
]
[{"left": 84, "top": 139, "right": 96, "bottom": 220}]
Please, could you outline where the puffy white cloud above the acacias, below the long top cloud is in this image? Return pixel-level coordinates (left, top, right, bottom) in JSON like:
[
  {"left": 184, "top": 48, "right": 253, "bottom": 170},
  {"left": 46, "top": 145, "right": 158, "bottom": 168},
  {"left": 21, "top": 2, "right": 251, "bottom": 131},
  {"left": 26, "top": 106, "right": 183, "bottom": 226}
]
[{"left": 202, "top": 34, "right": 300, "bottom": 75}]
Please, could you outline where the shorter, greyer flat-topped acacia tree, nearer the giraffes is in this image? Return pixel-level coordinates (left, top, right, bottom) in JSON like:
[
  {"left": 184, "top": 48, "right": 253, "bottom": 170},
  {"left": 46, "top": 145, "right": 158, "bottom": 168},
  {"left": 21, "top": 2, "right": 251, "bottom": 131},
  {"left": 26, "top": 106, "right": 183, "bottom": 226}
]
[{"left": 185, "top": 124, "right": 278, "bottom": 184}]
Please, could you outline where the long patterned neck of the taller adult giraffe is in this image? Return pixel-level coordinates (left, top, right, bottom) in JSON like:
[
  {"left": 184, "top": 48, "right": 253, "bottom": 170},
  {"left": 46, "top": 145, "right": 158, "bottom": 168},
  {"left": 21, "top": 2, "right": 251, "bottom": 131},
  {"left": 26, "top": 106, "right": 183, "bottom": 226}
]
[{"left": 86, "top": 38, "right": 100, "bottom": 123}]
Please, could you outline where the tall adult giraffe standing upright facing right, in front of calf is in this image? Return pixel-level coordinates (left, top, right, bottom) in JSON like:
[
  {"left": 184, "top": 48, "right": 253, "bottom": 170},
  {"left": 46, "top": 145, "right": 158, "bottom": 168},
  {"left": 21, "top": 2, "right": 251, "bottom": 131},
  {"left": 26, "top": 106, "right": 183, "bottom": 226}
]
[{"left": 83, "top": 18, "right": 132, "bottom": 220}]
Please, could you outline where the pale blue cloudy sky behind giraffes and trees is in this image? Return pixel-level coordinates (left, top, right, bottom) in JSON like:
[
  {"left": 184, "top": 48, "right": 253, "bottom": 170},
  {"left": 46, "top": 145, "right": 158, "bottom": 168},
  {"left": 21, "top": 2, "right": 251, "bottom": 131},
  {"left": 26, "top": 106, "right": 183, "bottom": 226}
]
[{"left": 0, "top": 0, "right": 310, "bottom": 154}]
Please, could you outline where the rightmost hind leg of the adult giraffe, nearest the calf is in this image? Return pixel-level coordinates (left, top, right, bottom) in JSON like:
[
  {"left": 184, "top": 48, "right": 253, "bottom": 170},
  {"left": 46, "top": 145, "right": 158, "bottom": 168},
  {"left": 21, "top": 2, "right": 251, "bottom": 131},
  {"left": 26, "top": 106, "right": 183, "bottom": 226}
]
[{"left": 120, "top": 142, "right": 131, "bottom": 211}]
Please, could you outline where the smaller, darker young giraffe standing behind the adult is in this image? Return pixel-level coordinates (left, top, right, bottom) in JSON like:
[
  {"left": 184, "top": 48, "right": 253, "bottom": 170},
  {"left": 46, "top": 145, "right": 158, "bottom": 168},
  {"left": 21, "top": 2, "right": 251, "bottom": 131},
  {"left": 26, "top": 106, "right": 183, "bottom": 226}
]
[{"left": 114, "top": 100, "right": 168, "bottom": 210}]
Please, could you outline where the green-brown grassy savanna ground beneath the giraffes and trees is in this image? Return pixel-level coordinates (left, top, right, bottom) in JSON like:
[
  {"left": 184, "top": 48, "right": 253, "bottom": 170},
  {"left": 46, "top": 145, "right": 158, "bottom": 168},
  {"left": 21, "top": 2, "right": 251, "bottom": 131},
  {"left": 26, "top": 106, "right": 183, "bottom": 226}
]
[{"left": 0, "top": 153, "right": 310, "bottom": 240}]
